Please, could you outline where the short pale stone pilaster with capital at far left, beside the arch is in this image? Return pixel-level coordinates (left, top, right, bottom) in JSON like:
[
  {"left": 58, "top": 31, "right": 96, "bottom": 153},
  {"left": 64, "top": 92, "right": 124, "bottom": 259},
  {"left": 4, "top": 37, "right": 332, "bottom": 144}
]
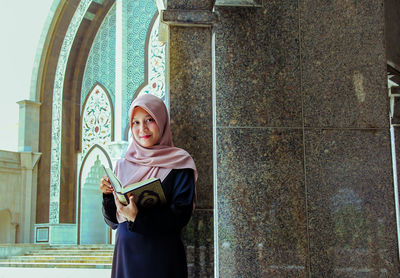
[{"left": 17, "top": 100, "right": 41, "bottom": 152}]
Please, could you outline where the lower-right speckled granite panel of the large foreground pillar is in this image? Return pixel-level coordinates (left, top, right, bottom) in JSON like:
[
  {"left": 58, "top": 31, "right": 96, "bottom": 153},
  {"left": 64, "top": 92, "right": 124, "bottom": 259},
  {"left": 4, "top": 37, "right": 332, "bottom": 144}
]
[{"left": 305, "top": 129, "right": 399, "bottom": 277}]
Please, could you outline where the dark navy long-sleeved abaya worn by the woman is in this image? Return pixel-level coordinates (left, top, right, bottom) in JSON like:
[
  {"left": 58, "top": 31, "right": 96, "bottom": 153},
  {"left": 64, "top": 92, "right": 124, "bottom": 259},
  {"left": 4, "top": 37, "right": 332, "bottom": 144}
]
[{"left": 103, "top": 169, "right": 194, "bottom": 278}]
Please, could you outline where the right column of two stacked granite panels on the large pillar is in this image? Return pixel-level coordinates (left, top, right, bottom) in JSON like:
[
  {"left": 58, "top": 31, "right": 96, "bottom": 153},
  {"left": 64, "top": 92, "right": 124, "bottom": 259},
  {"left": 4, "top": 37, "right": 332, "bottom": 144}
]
[{"left": 299, "top": 0, "right": 399, "bottom": 277}]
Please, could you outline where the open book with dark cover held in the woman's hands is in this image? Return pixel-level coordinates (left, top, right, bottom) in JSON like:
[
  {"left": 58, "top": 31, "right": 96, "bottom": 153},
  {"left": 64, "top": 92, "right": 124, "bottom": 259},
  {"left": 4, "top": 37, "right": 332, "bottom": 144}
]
[{"left": 103, "top": 166, "right": 167, "bottom": 210}]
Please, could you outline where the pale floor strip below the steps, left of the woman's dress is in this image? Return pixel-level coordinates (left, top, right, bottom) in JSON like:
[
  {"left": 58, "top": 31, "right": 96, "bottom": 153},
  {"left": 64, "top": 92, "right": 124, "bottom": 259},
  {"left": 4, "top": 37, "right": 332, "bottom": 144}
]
[{"left": 0, "top": 267, "right": 111, "bottom": 278}]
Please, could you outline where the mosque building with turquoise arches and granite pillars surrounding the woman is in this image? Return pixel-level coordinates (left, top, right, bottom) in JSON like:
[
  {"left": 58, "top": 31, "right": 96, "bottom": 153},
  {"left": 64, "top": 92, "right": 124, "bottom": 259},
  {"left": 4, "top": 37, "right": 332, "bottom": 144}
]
[{"left": 0, "top": 0, "right": 400, "bottom": 277}]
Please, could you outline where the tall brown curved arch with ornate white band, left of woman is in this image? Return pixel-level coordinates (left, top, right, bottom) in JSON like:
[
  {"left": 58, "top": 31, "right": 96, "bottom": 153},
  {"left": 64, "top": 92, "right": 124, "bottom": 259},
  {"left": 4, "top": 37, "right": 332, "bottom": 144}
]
[{"left": 35, "top": 0, "right": 115, "bottom": 224}]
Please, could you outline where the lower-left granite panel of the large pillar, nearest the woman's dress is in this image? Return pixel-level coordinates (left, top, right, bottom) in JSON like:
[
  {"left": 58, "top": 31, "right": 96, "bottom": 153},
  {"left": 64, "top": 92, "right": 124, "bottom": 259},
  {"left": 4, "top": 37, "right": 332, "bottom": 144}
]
[{"left": 217, "top": 128, "right": 307, "bottom": 277}]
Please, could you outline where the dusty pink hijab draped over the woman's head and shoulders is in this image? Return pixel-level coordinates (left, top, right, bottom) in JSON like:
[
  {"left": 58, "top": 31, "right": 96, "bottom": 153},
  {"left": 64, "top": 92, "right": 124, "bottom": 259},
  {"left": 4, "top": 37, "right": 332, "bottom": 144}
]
[{"left": 115, "top": 94, "right": 197, "bottom": 189}]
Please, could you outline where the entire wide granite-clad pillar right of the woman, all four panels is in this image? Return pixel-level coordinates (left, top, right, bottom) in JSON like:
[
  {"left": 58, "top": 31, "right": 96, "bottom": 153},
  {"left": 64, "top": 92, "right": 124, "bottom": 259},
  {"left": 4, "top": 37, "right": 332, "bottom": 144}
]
[{"left": 214, "top": 0, "right": 399, "bottom": 277}]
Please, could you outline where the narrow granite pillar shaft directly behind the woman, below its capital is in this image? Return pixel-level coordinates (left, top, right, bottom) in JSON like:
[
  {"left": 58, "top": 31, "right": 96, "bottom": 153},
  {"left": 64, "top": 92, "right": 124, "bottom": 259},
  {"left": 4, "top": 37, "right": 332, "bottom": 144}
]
[{"left": 169, "top": 26, "right": 213, "bottom": 208}]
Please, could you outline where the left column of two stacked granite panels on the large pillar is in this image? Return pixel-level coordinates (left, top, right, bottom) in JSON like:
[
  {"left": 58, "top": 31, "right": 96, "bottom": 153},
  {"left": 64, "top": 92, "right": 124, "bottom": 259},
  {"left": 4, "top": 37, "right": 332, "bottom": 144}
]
[{"left": 215, "top": 1, "right": 308, "bottom": 277}]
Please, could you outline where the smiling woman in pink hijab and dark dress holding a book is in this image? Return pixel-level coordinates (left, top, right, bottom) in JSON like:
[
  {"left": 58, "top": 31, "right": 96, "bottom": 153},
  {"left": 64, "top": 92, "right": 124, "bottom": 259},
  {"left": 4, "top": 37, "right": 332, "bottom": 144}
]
[{"left": 100, "top": 94, "right": 197, "bottom": 278}]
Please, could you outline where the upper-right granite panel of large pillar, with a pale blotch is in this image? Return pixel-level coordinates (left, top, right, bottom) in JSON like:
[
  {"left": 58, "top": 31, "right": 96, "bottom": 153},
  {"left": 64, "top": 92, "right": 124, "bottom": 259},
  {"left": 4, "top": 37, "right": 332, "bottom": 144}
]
[{"left": 299, "top": 0, "right": 389, "bottom": 128}]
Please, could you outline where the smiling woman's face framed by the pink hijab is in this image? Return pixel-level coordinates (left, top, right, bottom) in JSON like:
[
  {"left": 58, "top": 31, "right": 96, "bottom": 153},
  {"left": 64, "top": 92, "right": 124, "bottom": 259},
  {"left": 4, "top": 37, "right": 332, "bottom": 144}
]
[{"left": 131, "top": 107, "right": 161, "bottom": 148}]
